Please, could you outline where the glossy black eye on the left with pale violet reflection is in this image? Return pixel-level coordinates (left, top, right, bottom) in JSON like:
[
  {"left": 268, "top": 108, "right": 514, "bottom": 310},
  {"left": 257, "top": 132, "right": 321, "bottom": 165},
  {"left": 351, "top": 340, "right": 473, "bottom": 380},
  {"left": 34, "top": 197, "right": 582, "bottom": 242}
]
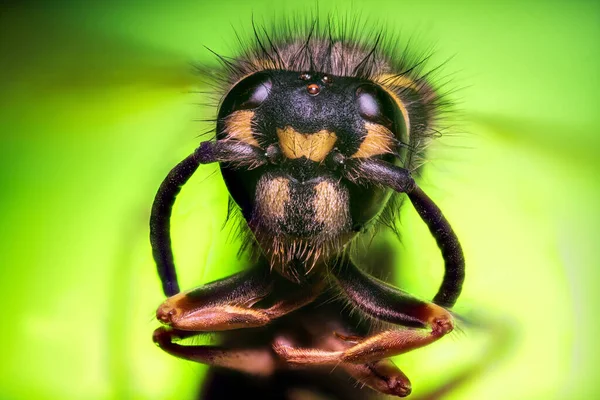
[{"left": 221, "top": 73, "right": 273, "bottom": 115}]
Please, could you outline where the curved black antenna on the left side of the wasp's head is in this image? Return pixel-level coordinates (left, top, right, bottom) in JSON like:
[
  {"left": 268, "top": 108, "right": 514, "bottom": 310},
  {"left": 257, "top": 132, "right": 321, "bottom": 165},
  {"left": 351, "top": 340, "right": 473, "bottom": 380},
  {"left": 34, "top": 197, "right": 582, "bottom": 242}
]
[{"left": 150, "top": 141, "right": 265, "bottom": 296}]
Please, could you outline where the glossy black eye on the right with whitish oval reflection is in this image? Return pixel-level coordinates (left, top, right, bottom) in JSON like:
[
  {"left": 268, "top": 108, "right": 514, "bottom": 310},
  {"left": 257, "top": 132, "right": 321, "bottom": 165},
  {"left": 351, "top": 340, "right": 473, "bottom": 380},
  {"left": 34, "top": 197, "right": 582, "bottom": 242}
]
[{"left": 355, "top": 83, "right": 398, "bottom": 132}]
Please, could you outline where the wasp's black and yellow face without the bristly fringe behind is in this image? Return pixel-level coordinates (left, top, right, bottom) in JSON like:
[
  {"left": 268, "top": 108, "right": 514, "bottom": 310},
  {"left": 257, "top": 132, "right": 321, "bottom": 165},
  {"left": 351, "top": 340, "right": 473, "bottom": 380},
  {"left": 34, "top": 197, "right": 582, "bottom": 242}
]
[{"left": 217, "top": 70, "right": 407, "bottom": 272}]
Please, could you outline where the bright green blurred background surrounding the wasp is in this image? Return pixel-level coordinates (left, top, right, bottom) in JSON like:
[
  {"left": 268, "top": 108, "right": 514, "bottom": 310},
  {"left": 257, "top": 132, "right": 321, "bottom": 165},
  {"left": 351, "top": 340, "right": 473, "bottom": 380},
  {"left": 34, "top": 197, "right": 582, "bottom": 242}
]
[{"left": 0, "top": 0, "right": 600, "bottom": 400}]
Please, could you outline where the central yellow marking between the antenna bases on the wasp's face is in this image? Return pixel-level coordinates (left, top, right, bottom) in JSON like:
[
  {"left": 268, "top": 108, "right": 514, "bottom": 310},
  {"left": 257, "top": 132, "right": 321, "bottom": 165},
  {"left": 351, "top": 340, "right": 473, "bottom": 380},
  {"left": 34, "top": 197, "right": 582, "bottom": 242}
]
[{"left": 277, "top": 126, "right": 337, "bottom": 162}]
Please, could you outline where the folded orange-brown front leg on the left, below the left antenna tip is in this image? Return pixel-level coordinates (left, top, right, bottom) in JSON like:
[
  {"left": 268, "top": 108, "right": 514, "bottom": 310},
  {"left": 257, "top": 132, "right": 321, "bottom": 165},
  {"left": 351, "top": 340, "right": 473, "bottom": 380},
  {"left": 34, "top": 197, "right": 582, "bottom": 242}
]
[{"left": 153, "top": 265, "right": 323, "bottom": 375}]
